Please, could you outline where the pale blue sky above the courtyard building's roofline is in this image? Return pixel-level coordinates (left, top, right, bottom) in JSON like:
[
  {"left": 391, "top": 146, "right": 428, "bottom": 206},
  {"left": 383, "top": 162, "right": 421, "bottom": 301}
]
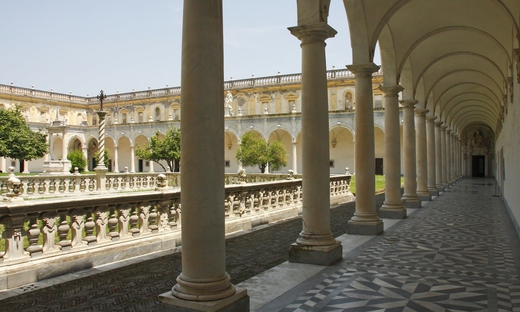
[{"left": 0, "top": 0, "right": 376, "bottom": 96}]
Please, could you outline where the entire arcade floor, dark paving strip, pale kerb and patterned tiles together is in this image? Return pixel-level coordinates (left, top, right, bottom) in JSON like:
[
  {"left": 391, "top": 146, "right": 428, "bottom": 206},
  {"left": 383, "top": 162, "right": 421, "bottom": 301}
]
[{"left": 0, "top": 179, "right": 520, "bottom": 312}]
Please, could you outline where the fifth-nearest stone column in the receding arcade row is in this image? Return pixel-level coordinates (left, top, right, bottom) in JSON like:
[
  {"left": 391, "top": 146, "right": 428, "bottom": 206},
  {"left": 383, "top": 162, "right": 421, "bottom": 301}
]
[{"left": 401, "top": 100, "right": 421, "bottom": 208}]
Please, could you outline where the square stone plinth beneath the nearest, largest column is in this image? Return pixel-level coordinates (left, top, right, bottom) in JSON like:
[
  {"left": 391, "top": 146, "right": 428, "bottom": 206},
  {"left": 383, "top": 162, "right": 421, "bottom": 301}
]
[{"left": 154, "top": 288, "right": 249, "bottom": 312}]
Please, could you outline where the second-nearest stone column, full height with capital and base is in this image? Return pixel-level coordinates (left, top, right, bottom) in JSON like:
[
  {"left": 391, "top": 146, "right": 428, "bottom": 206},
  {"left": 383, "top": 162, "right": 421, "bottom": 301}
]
[{"left": 289, "top": 23, "right": 343, "bottom": 265}]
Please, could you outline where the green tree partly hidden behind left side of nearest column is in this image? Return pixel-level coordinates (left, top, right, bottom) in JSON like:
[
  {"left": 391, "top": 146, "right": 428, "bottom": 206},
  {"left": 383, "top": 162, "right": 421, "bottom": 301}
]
[{"left": 135, "top": 126, "right": 181, "bottom": 172}]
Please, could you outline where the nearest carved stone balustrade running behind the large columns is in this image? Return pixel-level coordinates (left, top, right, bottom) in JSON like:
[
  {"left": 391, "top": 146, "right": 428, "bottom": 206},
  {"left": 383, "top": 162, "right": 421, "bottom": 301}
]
[{"left": 0, "top": 175, "right": 351, "bottom": 276}]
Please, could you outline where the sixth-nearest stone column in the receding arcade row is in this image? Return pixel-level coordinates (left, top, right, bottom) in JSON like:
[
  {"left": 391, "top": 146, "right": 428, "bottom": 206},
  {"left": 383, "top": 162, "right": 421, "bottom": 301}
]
[{"left": 415, "top": 109, "right": 432, "bottom": 201}]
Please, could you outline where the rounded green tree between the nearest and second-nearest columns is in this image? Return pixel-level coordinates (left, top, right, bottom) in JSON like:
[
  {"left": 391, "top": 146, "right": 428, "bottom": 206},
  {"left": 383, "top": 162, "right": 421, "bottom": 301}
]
[{"left": 236, "top": 131, "right": 287, "bottom": 173}]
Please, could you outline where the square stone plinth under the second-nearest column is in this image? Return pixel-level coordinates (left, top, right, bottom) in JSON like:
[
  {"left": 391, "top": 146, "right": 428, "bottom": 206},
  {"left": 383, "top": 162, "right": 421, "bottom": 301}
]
[{"left": 289, "top": 241, "right": 343, "bottom": 265}]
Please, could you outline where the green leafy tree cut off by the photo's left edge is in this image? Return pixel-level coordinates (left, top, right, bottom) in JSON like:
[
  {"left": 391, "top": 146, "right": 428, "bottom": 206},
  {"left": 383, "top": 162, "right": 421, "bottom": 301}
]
[{"left": 0, "top": 106, "right": 47, "bottom": 160}]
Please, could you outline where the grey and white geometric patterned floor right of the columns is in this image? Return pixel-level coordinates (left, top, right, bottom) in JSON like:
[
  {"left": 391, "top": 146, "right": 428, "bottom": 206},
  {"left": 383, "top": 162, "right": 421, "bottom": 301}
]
[{"left": 266, "top": 179, "right": 520, "bottom": 312}]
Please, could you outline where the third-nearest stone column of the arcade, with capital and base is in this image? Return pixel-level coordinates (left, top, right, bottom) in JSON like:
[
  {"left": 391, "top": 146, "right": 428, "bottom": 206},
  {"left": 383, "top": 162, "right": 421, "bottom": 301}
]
[{"left": 347, "top": 63, "right": 383, "bottom": 235}]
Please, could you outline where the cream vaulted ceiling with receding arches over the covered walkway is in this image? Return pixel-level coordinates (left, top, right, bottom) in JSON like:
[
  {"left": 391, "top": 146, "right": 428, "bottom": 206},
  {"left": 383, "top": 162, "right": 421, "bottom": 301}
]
[{"left": 343, "top": 0, "right": 520, "bottom": 139}]
